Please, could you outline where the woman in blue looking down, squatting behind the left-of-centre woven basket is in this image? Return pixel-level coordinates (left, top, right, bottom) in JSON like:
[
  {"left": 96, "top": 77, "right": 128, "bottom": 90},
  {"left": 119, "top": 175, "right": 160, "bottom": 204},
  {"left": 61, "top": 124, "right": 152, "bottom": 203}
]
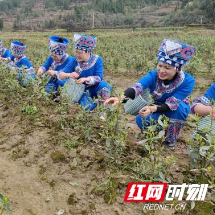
[{"left": 58, "top": 34, "right": 112, "bottom": 110}]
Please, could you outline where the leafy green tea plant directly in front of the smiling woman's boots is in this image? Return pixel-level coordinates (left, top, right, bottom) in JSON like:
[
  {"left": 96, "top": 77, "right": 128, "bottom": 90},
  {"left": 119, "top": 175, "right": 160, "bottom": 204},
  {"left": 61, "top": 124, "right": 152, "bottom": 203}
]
[{"left": 137, "top": 116, "right": 176, "bottom": 182}]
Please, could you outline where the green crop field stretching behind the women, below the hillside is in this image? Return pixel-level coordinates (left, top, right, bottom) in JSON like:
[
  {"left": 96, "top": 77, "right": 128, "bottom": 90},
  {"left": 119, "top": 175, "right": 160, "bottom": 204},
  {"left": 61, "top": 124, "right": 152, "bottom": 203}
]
[{"left": 1, "top": 27, "right": 215, "bottom": 77}]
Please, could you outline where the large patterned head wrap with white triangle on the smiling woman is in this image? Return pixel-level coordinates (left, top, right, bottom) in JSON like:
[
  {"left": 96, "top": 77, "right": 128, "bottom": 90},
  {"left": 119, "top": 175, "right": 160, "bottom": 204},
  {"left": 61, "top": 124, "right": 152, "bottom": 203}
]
[{"left": 157, "top": 39, "right": 196, "bottom": 68}]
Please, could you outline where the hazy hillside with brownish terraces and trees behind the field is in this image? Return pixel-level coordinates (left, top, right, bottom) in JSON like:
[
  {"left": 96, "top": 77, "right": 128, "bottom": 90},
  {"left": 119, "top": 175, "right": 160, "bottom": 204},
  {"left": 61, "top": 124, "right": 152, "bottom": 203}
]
[{"left": 0, "top": 0, "right": 198, "bottom": 31}]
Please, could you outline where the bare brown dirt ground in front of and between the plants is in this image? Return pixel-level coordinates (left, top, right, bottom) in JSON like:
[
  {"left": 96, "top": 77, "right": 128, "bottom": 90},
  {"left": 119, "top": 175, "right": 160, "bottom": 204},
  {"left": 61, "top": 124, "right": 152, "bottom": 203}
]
[{"left": 0, "top": 74, "right": 214, "bottom": 215}]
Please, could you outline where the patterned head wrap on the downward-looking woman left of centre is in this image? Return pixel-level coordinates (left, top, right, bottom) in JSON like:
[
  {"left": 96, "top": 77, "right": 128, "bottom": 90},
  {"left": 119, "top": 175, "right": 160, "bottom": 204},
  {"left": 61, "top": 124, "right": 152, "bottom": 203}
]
[{"left": 73, "top": 34, "right": 97, "bottom": 52}]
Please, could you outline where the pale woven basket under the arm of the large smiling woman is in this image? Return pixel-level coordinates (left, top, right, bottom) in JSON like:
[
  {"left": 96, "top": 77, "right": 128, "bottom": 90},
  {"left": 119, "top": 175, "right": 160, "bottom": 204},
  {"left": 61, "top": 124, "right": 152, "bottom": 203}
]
[{"left": 124, "top": 89, "right": 152, "bottom": 115}]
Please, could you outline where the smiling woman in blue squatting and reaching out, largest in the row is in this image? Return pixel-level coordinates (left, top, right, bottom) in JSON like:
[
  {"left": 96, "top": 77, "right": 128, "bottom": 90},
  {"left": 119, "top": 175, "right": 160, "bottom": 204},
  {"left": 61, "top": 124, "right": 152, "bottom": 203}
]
[{"left": 105, "top": 39, "right": 195, "bottom": 148}]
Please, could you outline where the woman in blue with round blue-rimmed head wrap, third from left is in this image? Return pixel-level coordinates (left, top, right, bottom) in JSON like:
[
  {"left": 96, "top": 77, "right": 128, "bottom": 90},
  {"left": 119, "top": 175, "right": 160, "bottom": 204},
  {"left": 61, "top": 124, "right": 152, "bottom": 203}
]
[{"left": 37, "top": 36, "right": 73, "bottom": 94}]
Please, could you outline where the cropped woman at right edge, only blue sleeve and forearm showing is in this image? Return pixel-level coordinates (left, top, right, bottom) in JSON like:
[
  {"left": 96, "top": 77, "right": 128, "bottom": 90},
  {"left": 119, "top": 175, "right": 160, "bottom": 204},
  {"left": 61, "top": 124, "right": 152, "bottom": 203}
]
[{"left": 191, "top": 83, "right": 215, "bottom": 120}]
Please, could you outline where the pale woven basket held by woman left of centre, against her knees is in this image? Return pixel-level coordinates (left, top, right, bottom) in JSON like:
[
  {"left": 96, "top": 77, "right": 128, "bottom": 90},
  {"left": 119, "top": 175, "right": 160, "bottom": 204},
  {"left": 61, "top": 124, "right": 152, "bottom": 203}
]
[{"left": 63, "top": 78, "right": 85, "bottom": 102}]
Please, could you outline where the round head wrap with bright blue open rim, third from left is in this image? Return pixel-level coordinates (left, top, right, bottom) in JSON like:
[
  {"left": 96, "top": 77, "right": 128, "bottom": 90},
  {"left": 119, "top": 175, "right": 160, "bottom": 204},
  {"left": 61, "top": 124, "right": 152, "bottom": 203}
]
[{"left": 49, "top": 36, "right": 69, "bottom": 55}]
